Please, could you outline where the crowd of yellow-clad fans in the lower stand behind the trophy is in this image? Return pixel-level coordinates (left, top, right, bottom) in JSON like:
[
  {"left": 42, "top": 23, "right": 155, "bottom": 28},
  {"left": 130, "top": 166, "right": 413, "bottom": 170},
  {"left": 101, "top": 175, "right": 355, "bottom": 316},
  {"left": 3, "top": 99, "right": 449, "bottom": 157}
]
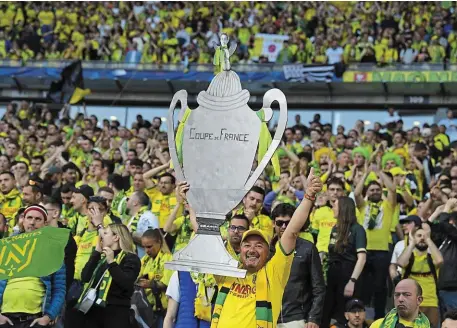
[{"left": 0, "top": 102, "right": 457, "bottom": 328}]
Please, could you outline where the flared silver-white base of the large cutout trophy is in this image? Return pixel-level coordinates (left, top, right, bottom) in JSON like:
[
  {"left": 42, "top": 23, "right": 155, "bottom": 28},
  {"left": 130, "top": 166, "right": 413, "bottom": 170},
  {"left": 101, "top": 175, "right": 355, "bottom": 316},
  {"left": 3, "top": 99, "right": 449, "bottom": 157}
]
[{"left": 165, "top": 234, "right": 246, "bottom": 278}]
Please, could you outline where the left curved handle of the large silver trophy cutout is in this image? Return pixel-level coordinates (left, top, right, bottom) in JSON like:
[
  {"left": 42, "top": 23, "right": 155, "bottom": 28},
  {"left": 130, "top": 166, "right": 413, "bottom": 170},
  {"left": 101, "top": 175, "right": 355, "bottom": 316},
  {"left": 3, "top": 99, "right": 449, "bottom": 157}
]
[{"left": 168, "top": 90, "right": 187, "bottom": 181}]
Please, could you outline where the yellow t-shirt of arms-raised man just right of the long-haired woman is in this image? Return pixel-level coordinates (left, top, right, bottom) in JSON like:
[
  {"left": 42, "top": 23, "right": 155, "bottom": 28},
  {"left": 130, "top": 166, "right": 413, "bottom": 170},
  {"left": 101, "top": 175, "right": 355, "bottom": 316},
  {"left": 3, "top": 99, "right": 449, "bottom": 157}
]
[{"left": 357, "top": 200, "right": 395, "bottom": 251}]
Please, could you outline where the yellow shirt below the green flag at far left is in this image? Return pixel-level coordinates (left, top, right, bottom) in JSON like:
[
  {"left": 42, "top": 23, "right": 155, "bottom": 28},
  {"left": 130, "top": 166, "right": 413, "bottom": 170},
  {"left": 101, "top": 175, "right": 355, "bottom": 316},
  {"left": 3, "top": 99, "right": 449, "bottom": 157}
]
[{"left": 1, "top": 277, "right": 46, "bottom": 314}]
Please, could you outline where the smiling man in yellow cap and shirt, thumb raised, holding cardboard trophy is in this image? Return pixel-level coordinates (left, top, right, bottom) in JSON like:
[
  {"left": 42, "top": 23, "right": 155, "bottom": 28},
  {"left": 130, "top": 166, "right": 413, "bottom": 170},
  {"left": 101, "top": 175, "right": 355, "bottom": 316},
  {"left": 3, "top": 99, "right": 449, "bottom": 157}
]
[{"left": 211, "top": 169, "right": 322, "bottom": 328}]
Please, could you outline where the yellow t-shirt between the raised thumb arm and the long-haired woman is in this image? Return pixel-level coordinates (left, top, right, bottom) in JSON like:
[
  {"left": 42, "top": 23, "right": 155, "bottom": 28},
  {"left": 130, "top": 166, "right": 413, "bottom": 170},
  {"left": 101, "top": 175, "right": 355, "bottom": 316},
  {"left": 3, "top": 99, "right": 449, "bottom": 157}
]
[{"left": 310, "top": 206, "right": 336, "bottom": 253}]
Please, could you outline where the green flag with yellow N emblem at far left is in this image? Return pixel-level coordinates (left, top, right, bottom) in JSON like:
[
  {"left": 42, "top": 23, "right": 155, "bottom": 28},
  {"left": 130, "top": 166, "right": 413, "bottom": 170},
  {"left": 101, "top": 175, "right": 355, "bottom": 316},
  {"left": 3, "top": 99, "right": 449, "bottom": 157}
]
[{"left": 0, "top": 227, "right": 70, "bottom": 280}]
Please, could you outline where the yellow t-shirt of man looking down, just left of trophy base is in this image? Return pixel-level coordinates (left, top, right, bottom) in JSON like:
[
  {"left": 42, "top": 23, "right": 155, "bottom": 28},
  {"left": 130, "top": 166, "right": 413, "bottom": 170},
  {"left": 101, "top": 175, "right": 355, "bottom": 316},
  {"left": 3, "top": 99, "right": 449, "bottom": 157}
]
[{"left": 139, "top": 251, "right": 173, "bottom": 310}]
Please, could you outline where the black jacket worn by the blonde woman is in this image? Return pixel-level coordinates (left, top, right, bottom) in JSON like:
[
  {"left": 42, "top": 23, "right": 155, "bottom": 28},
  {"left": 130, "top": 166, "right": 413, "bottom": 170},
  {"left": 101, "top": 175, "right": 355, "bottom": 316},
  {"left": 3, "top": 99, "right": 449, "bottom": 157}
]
[{"left": 81, "top": 250, "right": 141, "bottom": 307}]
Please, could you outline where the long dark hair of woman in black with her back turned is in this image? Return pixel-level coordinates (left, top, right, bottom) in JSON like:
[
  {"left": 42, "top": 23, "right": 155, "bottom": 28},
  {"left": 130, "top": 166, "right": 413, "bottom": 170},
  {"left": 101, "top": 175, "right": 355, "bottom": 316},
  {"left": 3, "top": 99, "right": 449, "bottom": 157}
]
[{"left": 335, "top": 196, "right": 357, "bottom": 253}]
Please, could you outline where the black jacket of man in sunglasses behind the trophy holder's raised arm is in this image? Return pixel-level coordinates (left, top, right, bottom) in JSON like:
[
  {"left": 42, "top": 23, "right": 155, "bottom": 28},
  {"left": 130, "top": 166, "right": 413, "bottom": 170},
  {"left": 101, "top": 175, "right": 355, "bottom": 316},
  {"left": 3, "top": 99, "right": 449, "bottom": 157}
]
[{"left": 272, "top": 238, "right": 325, "bottom": 325}]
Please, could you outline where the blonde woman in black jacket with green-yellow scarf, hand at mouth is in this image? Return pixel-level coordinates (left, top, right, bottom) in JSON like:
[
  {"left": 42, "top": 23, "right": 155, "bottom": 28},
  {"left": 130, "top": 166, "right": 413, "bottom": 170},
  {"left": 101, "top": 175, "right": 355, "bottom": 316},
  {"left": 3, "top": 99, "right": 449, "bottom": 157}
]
[{"left": 71, "top": 224, "right": 141, "bottom": 328}]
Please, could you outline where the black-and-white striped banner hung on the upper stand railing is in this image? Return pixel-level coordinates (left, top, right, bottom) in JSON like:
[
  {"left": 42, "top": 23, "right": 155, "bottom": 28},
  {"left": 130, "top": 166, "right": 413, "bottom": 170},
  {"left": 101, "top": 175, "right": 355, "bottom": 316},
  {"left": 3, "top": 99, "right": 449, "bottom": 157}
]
[{"left": 284, "top": 64, "right": 335, "bottom": 82}]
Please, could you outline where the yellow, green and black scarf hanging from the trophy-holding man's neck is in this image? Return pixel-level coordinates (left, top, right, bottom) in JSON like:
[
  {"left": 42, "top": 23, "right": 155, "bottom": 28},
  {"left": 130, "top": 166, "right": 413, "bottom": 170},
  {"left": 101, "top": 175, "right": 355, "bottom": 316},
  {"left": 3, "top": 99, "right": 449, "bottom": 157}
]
[{"left": 211, "top": 267, "right": 273, "bottom": 328}]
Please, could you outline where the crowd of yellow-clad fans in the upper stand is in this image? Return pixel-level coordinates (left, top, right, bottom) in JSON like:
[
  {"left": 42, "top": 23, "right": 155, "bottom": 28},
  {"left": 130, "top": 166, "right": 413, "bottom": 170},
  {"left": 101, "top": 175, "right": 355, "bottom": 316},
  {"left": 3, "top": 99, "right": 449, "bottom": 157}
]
[{"left": 0, "top": 1, "right": 457, "bottom": 64}]
